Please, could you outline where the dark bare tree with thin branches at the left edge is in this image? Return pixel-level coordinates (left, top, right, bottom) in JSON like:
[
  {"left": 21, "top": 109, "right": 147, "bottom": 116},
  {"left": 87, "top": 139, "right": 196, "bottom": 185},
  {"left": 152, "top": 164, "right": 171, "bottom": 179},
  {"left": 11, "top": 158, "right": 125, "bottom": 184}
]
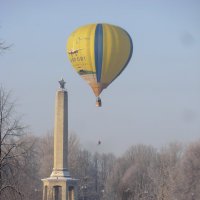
[{"left": 0, "top": 87, "right": 25, "bottom": 196}]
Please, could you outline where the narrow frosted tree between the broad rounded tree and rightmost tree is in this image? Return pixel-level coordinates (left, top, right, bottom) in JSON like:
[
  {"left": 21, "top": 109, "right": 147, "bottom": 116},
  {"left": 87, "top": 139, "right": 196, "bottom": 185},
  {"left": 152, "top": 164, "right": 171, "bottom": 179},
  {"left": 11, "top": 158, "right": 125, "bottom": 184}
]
[{"left": 149, "top": 143, "right": 182, "bottom": 200}]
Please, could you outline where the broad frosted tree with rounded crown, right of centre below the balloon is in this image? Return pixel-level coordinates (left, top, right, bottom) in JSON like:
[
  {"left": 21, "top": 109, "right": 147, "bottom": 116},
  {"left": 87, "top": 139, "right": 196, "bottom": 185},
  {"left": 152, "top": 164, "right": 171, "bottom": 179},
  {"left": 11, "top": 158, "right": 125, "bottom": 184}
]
[{"left": 105, "top": 145, "right": 156, "bottom": 200}]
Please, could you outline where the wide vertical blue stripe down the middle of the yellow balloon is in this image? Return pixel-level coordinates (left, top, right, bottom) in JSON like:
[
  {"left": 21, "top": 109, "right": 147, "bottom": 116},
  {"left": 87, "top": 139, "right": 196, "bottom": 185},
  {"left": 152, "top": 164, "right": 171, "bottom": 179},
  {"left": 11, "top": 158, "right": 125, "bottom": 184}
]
[{"left": 94, "top": 24, "right": 103, "bottom": 82}]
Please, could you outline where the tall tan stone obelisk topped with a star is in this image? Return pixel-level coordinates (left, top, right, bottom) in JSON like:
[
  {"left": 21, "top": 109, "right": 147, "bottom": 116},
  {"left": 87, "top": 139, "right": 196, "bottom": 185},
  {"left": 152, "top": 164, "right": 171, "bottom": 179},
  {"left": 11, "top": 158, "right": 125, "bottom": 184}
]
[{"left": 42, "top": 79, "right": 77, "bottom": 200}]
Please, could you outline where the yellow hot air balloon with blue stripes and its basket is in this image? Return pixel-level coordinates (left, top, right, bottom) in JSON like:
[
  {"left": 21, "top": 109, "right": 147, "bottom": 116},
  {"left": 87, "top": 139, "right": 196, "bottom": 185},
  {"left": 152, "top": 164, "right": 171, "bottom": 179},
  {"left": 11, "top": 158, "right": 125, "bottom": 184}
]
[{"left": 67, "top": 24, "right": 133, "bottom": 107}]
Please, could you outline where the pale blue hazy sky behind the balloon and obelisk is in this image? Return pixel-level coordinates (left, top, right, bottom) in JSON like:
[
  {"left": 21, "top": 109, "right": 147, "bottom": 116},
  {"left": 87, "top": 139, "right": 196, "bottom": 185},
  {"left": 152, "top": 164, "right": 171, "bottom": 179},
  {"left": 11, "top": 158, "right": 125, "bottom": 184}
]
[{"left": 0, "top": 0, "right": 200, "bottom": 155}]
